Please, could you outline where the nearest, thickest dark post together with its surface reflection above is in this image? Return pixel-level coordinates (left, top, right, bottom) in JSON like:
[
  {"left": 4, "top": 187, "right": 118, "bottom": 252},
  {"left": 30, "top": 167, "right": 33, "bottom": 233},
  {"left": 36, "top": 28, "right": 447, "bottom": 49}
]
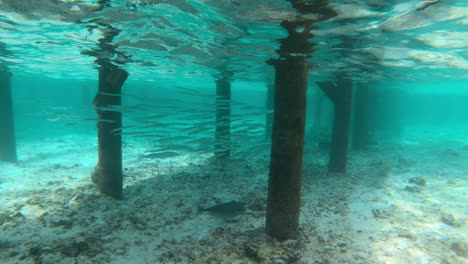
[{"left": 266, "top": 0, "right": 336, "bottom": 240}]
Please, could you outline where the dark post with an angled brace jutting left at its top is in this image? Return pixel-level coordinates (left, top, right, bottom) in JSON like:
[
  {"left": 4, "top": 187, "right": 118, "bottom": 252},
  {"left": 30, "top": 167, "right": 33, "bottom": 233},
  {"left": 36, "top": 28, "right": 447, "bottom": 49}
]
[{"left": 317, "top": 76, "right": 353, "bottom": 172}]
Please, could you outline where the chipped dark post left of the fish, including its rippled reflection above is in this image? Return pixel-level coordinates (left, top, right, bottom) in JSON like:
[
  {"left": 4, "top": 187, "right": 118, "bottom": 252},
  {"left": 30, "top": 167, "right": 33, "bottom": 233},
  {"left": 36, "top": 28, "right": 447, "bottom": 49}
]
[{"left": 82, "top": 20, "right": 128, "bottom": 199}]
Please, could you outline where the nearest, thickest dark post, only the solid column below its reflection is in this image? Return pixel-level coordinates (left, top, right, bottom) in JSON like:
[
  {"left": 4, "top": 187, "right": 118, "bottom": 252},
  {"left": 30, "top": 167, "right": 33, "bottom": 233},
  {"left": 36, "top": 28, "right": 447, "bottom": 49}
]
[{"left": 266, "top": 56, "right": 309, "bottom": 240}]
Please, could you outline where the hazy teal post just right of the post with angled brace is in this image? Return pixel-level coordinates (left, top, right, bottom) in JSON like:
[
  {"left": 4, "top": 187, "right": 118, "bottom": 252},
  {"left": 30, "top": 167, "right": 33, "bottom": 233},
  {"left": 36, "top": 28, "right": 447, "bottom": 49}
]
[{"left": 352, "top": 82, "right": 370, "bottom": 149}]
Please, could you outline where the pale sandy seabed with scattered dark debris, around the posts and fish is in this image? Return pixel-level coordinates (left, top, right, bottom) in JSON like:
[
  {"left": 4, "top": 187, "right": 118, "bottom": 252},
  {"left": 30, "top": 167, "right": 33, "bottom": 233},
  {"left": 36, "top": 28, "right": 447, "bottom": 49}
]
[{"left": 0, "top": 135, "right": 468, "bottom": 264}]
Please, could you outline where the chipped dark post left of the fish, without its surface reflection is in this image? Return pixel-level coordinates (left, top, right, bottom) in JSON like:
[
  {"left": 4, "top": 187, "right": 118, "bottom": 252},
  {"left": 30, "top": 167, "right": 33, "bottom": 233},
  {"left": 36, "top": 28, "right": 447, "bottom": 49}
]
[{"left": 93, "top": 62, "right": 128, "bottom": 199}]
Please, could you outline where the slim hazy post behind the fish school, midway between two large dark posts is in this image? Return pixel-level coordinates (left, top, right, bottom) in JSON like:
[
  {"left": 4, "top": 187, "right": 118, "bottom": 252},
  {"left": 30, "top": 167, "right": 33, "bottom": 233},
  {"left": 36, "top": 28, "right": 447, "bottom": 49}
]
[{"left": 215, "top": 77, "right": 231, "bottom": 160}]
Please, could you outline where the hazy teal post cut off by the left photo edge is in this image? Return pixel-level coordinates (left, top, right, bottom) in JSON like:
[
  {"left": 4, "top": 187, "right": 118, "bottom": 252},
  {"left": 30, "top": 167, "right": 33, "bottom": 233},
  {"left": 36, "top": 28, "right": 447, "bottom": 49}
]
[{"left": 0, "top": 67, "right": 17, "bottom": 162}]
